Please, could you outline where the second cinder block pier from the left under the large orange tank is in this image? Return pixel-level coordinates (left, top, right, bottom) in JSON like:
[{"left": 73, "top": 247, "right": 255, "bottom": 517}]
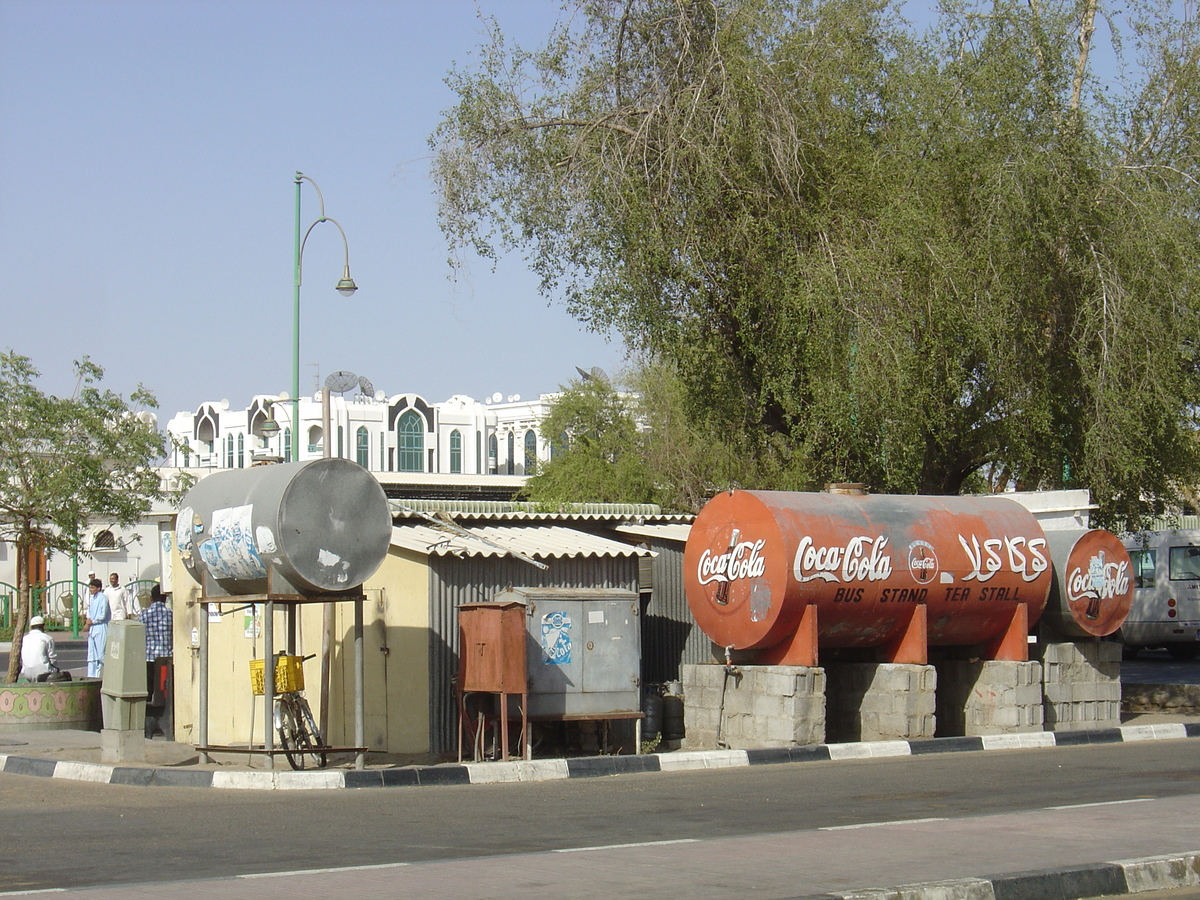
[{"left": 826, "top": 662, "right": 937, "bottom": 743}]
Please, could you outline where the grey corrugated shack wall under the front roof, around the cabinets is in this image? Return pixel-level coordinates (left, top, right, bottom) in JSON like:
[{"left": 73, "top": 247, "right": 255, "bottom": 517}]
[{"left": 430, "top": 556, "right": 637, "bottom": 755}]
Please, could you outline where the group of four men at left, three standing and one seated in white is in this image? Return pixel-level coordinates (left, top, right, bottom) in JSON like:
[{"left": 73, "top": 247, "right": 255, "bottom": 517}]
[{"left": 20, "top": 572, "right": 173, "bottom": 682}]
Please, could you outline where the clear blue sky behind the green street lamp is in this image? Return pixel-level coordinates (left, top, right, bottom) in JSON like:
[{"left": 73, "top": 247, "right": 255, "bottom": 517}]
[{"left": 0, "top": 0, "right": 624, "bottom": 424}]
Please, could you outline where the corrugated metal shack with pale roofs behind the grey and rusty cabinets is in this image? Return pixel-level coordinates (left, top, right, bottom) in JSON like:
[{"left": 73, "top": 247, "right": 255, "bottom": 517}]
[{"left": 391, "top": 500, "right": 710, "bottom": 755}]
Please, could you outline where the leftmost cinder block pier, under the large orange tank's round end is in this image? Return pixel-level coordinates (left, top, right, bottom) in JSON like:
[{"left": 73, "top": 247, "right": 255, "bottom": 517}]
[{"left": 682, "top": 665, "right": 826, "bottom": 750}]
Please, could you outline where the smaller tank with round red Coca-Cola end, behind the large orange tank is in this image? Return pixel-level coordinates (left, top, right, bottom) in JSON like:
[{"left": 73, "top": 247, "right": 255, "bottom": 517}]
[{"left": 1042, "top": 528, "right": 1134, "bottom": 637}]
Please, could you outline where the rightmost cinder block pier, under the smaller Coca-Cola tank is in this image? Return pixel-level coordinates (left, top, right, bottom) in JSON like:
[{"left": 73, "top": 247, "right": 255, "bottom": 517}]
[{"left": 1036, "top": 641, "right": 1121, "bottom": 731}]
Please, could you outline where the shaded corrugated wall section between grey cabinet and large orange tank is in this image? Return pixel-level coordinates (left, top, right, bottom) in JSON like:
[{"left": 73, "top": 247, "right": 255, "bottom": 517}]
[{"left": 642, "top": 539, "right": 713, "bottom": 684}]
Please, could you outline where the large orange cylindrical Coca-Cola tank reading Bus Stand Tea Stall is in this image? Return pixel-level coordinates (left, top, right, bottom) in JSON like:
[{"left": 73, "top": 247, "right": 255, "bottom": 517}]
[{"left": 684, "top": 491, "right": 1052, "bottom": 650}]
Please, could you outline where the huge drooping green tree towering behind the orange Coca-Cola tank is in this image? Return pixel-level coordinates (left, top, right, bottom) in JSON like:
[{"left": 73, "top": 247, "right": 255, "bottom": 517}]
[{"left": 431, "top": 0, "right": 1200, "bottom": 518}]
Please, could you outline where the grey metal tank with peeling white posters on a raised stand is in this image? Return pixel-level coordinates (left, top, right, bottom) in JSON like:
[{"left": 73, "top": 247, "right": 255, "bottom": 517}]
[{"left": 175, "top": 458, "right": 391, "bottom": 595}]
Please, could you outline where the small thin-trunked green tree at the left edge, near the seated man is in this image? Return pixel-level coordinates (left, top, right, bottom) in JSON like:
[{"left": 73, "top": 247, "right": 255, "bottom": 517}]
[{"left": 0, "top": 350, "right": 163, "bottom": 682}]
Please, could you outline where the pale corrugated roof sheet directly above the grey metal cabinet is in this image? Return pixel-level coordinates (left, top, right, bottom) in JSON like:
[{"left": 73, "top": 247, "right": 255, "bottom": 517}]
[{"left": 391, "top": 523, "right": 654, "bottom": 559}]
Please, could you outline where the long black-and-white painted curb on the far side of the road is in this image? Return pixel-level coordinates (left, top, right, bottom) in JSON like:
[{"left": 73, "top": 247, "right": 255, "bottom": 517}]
[{"left": 0, "top": 722, "right": 1200, "bottom": 791}]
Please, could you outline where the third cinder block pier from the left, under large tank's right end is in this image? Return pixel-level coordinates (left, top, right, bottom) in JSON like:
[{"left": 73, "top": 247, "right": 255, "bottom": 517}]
[{"left": 937, "top": 660, "right": 1043, "bottom": 737}]
